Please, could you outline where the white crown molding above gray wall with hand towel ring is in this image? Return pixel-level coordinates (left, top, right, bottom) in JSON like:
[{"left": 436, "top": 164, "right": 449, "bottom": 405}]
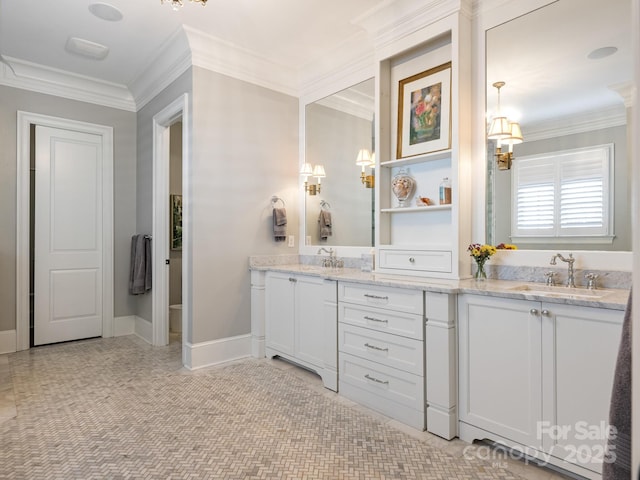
[{"left": 184, "top": 27, "right": 299, "bottom": 96}]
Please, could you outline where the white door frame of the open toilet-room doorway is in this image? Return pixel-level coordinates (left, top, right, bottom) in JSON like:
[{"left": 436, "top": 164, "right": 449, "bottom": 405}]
[{"left": 151, "top": 93, "right": 191, "bottom": 356}]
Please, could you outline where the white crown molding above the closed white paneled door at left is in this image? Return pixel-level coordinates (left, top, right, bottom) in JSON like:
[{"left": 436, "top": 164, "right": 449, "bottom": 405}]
[{"left": 0, "top": 56, "right": 136, "bottom": 112}]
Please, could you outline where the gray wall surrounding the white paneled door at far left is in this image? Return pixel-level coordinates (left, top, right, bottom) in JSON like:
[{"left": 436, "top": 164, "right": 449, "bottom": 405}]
[{"left": 0, "top": 86, "right": 136, "bottom": 331}]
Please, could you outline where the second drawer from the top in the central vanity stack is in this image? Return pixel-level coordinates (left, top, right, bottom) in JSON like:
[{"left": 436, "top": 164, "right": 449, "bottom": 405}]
[{"left": 338, "top": 302, "right": 424, "bottom": 341}]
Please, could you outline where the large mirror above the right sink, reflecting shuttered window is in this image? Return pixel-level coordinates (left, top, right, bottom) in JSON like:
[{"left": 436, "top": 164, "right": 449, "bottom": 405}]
[{"left": 486, "top": 0, "right": 633, "bottom": 251}]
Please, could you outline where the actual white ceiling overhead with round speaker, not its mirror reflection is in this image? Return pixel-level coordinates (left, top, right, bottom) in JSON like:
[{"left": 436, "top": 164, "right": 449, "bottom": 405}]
[{"left": 0, "top": 0, "right": 389, "bottom": 89}]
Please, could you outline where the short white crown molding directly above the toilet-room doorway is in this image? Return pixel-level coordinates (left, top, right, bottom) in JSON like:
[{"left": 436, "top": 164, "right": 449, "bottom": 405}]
[{"left": 129, "top": 27, "right": 191, "bottom": 110}]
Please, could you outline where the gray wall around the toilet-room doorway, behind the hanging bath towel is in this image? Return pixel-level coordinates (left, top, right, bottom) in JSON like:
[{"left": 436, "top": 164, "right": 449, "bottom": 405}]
[{"left": 134, "top": 69, "right": 193, "bottom": 321}]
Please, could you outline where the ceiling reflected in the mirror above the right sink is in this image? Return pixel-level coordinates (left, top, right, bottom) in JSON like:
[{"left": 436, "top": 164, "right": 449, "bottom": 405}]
[{"left": 487, "top": 0, "right": 633, "bottom": 131}]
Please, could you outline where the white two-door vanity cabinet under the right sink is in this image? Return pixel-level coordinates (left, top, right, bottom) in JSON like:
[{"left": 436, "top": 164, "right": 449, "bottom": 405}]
[{"left": 458, "top": 294, "right": 624, "bottom": 478}]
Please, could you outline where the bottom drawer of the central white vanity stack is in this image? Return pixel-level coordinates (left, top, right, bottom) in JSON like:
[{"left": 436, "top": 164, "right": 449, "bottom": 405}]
[{"left": 339, "top": 352, "right": 424, "bottom": 420}]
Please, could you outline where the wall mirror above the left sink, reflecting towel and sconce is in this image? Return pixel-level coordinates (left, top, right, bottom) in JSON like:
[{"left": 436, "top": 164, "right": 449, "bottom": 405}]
[{"left": 304, "top": 79, "right": 375, "bottom": 247}]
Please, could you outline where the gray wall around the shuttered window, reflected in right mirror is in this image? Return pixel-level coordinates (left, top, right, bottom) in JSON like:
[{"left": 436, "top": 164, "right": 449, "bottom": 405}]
[{"left": 494, "top": 126, "right": 632, "bottom": 251}]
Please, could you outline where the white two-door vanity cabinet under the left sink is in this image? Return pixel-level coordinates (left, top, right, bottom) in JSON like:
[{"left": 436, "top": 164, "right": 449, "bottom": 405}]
[{"left": 265, "top": 272, "right": 338, "bottom": 391}]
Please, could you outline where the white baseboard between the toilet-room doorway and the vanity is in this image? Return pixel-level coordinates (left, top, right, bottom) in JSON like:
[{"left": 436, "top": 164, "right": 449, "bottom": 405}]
[{"left": 183, "top": 334, "right": 252, "bottom": 370}]
